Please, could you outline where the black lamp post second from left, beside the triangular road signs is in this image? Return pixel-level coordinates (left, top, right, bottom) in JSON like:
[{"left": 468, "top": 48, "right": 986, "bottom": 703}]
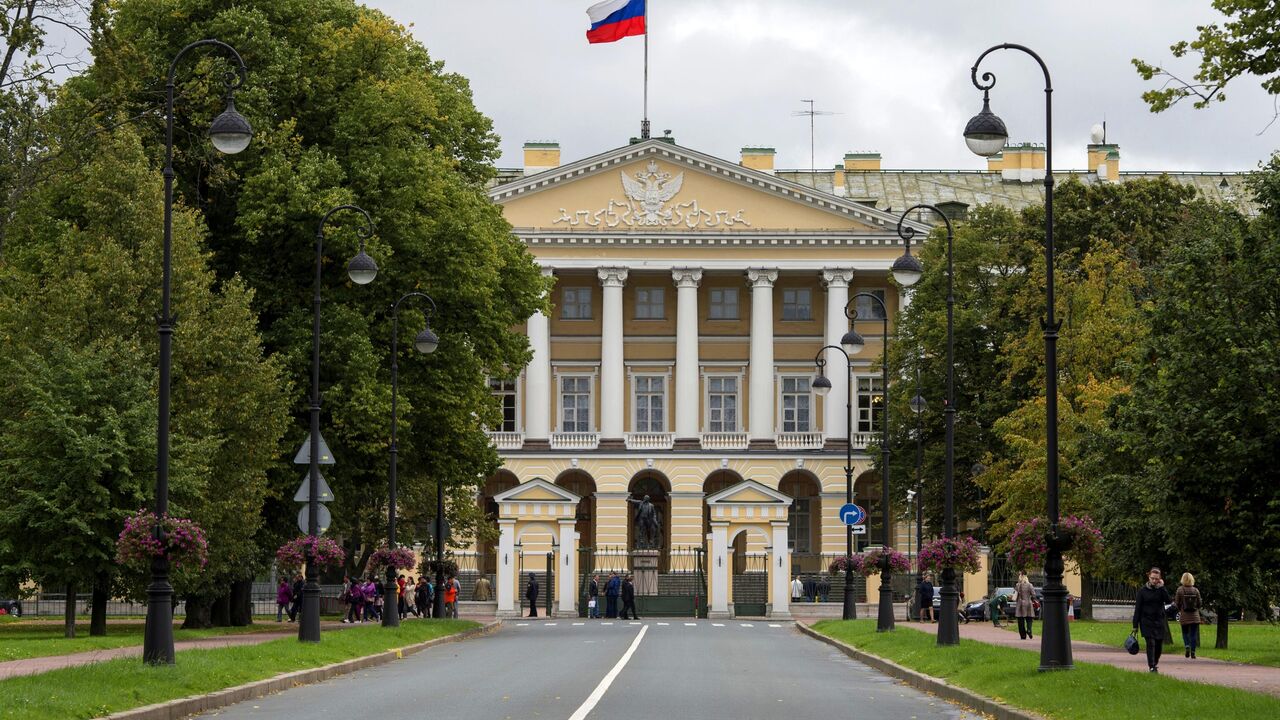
[{"left": 298, "top": 205, "right": 378, "bottom": 643}]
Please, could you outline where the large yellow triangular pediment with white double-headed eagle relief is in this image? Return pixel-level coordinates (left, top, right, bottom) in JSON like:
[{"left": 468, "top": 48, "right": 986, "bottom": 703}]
[{"left": 489, "top": 140, "right": 929, "bottom": 238}]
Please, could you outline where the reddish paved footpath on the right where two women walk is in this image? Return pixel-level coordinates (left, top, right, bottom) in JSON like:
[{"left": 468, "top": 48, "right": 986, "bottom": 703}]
[{"left": 855, "top": 620, "right": 1280, "bottom": 697}]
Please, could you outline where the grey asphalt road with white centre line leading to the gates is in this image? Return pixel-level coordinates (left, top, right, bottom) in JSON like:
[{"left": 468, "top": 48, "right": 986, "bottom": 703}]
[{"left": 202, "top": 619, "right": 980, "bottom": 720}]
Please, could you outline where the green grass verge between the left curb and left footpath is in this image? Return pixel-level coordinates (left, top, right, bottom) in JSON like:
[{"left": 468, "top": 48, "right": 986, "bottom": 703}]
[{"left": 0, "top": 620, "right": 477, "bottom": 720}]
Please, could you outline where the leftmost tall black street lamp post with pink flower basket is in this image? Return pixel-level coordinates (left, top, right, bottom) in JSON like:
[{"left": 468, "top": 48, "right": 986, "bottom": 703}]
[{"left": 142, "top": 40, "right": 253, "bottom": 665}]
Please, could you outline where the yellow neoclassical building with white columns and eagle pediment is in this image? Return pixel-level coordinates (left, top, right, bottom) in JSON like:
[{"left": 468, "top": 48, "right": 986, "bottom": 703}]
[{"left": 462, "top": 137, "right": 1239, "bottom": 618}]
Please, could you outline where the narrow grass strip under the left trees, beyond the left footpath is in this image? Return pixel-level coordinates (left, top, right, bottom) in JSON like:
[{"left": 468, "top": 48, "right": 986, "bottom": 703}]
[{"left": 0, "top": 621, "right": 297, "bottom": 662}]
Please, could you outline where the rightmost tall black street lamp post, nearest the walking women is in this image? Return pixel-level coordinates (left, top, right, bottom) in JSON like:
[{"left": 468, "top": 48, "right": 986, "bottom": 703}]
[{"left": 964, "top": 42, "right": 1073, "bottom": 670}]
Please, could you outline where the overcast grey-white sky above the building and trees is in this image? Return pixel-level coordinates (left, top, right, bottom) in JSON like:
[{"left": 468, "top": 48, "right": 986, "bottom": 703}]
[{"left": 366, "top": 0, "right": 1280, "bottom": 170}]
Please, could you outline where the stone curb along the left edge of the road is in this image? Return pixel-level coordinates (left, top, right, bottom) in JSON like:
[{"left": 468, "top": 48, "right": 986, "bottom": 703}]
[{"left": 104, "top": 620, "right": 502, "bottom": 720}]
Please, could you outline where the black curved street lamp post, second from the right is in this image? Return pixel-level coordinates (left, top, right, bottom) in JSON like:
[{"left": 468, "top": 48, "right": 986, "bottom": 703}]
[{"left": 897, "top": 204, "right": 960, "bottom": 646}]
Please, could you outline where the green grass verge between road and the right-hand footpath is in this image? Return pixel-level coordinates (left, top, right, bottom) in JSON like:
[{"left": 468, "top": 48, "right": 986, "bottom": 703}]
[{"left": 814, "top": 620, "right": 1280, "bottom": 720}]
